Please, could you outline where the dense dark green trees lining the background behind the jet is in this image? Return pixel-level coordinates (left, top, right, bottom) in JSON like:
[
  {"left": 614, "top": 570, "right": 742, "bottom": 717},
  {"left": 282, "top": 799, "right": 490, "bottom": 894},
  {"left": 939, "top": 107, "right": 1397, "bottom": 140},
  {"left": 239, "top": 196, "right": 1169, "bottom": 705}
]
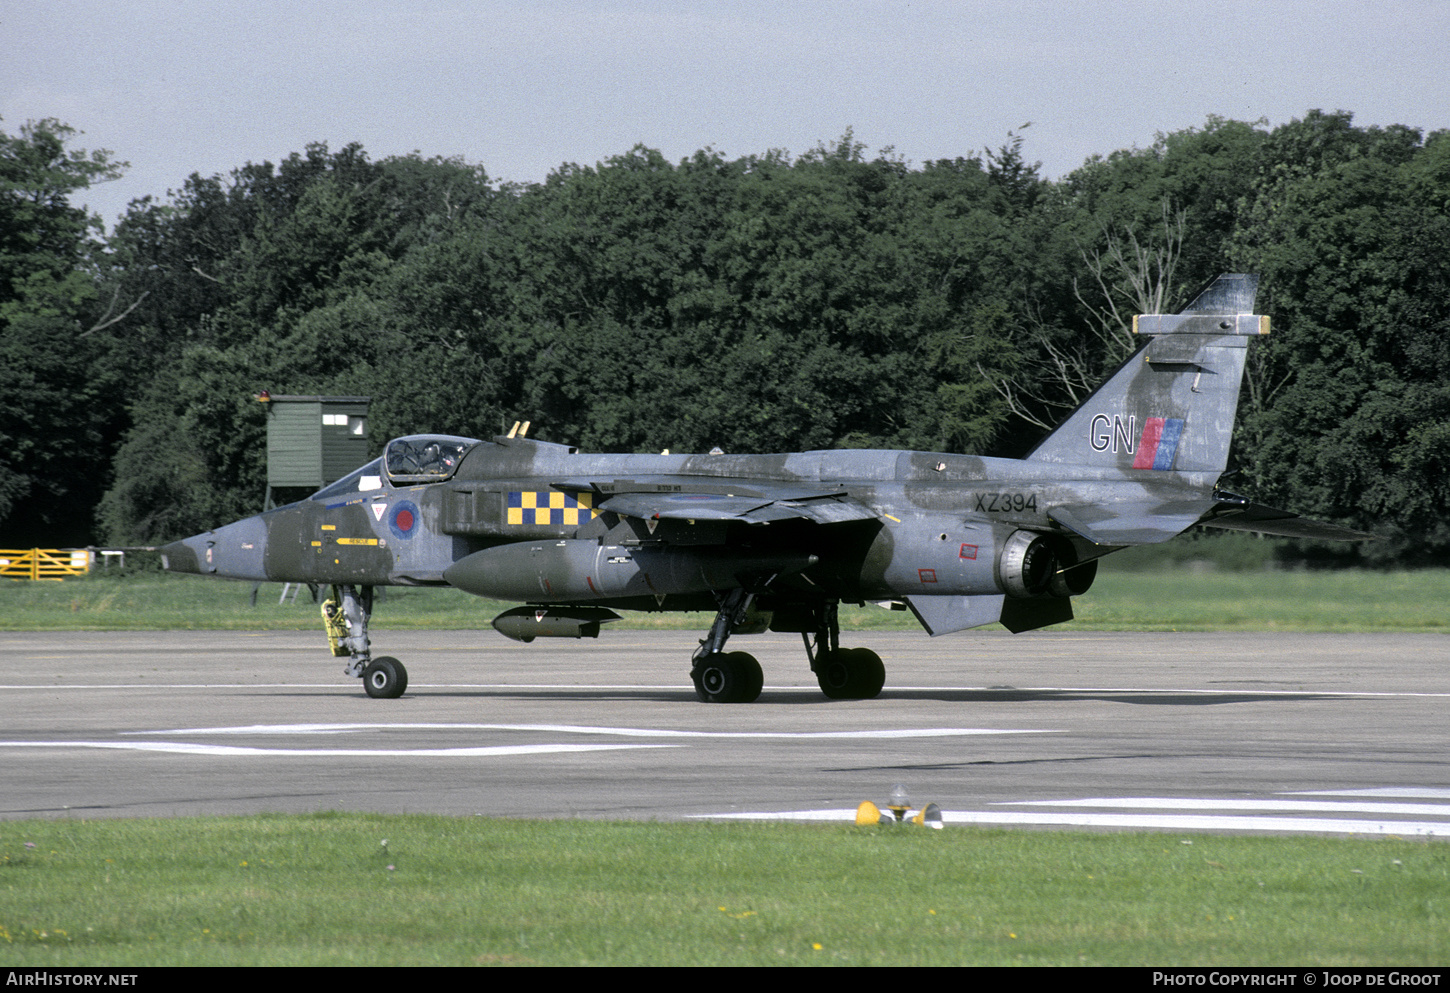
[{"left": 0, "top": 112, "right": 1450, "bottom": 562}]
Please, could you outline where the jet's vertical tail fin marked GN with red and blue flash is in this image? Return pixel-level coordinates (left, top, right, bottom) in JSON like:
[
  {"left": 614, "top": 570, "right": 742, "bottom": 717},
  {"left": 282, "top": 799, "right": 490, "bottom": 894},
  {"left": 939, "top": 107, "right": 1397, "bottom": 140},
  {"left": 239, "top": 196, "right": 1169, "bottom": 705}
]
[{"left": 1027, "top": 274, "right": 1269, "bottom": 473}]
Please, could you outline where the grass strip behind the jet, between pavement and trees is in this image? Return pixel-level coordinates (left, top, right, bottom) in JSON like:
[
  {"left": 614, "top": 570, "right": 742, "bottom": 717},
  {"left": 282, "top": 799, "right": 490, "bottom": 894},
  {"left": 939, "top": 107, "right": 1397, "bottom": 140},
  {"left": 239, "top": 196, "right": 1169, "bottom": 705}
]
[{"left": 0, "top": 564, "right": 1450, "bottom": 632}]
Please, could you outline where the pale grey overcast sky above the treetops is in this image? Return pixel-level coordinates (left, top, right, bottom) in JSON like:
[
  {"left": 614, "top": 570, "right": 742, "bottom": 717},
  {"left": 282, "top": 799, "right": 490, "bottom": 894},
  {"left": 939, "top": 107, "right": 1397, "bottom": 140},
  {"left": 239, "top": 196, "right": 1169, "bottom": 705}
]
[{"left": 0, "top": 0, "right": 1450, "bottom": 230}]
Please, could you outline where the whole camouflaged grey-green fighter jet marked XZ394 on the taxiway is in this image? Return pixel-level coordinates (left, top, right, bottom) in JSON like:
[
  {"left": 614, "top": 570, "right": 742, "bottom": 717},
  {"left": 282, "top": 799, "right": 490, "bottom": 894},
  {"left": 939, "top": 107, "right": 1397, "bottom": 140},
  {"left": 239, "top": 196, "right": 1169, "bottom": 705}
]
[{"left": 162, "top": 275, "right": 1373, "bottom": 703}]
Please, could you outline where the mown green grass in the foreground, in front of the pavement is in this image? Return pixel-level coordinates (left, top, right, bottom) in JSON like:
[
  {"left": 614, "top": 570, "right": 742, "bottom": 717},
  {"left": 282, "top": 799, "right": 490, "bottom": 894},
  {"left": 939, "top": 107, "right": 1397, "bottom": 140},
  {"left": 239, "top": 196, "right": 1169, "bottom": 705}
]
[{"left": 0, "top": 813, "right": 1450, "bottom": 967}]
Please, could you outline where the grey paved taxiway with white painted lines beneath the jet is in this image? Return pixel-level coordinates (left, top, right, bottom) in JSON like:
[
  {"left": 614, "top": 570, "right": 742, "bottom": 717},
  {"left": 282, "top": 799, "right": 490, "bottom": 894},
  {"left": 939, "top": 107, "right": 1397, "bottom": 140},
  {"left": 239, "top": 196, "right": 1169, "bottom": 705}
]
[{"left": 0, "top": 631, "right": 1450, "bottom": 835}]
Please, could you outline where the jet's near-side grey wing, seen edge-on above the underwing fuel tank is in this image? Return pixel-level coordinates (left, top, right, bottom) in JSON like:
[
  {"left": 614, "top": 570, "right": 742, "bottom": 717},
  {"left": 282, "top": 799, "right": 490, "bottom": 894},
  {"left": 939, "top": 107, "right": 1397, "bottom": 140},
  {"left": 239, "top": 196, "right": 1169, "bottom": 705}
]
[{"left": 596, "top": 484, "right": 877, "bottom": 525}]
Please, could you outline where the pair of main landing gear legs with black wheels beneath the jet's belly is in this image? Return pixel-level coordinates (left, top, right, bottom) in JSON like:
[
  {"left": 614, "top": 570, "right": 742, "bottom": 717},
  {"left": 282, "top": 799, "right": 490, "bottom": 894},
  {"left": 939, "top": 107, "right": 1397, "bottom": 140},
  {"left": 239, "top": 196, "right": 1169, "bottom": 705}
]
[{"left": 690, "top": 590, "right": 886, "bottom": 703}]
